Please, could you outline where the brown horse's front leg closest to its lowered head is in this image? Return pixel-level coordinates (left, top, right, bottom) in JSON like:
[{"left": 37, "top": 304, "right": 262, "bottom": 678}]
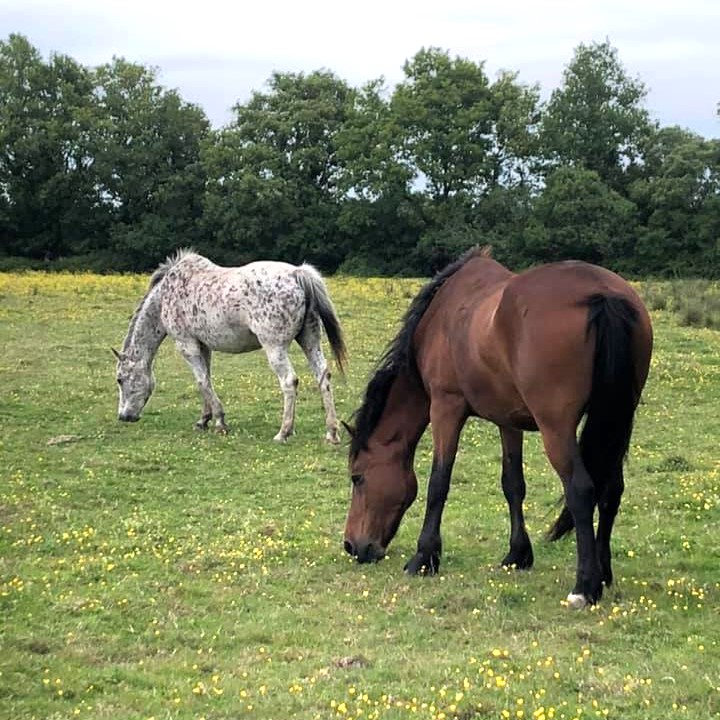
[{"left": 405, "top": 396, "right": 467, "bottom": 575}]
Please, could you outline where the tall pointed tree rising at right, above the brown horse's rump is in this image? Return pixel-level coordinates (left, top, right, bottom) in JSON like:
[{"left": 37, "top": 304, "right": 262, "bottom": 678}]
[{"left": 542, "top": 41, "right": 652, "bottom": 193}]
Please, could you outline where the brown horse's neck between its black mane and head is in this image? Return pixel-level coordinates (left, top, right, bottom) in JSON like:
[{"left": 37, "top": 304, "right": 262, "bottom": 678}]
[{"left": 368, "top": 372, "right": 430, "bottom": 465}]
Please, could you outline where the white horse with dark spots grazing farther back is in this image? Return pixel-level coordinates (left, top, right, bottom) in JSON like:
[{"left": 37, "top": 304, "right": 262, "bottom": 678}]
[{"left": 112, "top": 249, "right": 347, "bottom": 444}]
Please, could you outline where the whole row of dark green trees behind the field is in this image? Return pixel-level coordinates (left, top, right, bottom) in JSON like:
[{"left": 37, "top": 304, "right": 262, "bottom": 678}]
[{"left": 0, "top": 35, "right": 720, "bottom": 277}]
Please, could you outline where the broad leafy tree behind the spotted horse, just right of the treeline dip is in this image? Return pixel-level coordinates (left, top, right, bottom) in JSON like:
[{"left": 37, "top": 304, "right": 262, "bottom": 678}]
[{"left": 205, "top": 71, "right": 353, "bottom": 269}]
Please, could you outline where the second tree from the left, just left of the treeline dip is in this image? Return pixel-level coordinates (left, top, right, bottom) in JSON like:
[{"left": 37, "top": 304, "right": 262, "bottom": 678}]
[{"left": 94, "top": 58, "right": 208, "bottom": 269}]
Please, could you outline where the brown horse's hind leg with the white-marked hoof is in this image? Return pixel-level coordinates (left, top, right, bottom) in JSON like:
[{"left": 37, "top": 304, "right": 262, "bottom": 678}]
[{"left": 540, "top": 427, "right": 602, "bottom": 608}]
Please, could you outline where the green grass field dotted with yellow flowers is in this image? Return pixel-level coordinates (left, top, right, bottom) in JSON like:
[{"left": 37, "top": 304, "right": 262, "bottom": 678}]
[{"left": 0, "top": 273, "right": 720, "bottom": 720}]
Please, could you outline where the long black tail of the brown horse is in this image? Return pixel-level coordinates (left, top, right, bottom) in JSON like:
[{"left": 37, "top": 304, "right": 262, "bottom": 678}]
[{"left": 548, "top": 294, "right": 640, "bottom": 540}]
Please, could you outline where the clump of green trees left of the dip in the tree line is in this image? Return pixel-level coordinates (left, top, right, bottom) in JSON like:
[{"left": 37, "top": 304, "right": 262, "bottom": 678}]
[{"left": 0, "top": 35, "right": 208, "bottom": 269}]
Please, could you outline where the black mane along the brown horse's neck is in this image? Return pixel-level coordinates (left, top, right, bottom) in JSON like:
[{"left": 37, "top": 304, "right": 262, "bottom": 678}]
[{"left": 350, "top": 246, "right": 491, "bottom": 460}]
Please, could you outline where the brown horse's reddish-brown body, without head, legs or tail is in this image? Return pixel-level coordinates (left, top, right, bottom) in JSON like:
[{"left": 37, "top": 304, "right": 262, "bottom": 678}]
[{"left": 418, "top": 260, "right": 652, "bottom": 430}]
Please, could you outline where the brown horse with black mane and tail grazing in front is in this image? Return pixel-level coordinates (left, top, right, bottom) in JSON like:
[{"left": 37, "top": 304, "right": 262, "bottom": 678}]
[{"left": 345, "top": 249, "right": 652, "bottom": 607}]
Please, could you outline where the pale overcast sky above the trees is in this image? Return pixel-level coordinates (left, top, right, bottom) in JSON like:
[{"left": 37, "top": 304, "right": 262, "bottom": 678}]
[{"left": 0, "top": 0, "right": 720, "bottom": 137}]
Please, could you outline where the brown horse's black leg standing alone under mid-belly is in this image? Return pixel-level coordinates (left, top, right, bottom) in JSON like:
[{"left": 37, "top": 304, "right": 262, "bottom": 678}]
[{"left": 500, "top": 428, "right": 534, "bottom": 569}]
